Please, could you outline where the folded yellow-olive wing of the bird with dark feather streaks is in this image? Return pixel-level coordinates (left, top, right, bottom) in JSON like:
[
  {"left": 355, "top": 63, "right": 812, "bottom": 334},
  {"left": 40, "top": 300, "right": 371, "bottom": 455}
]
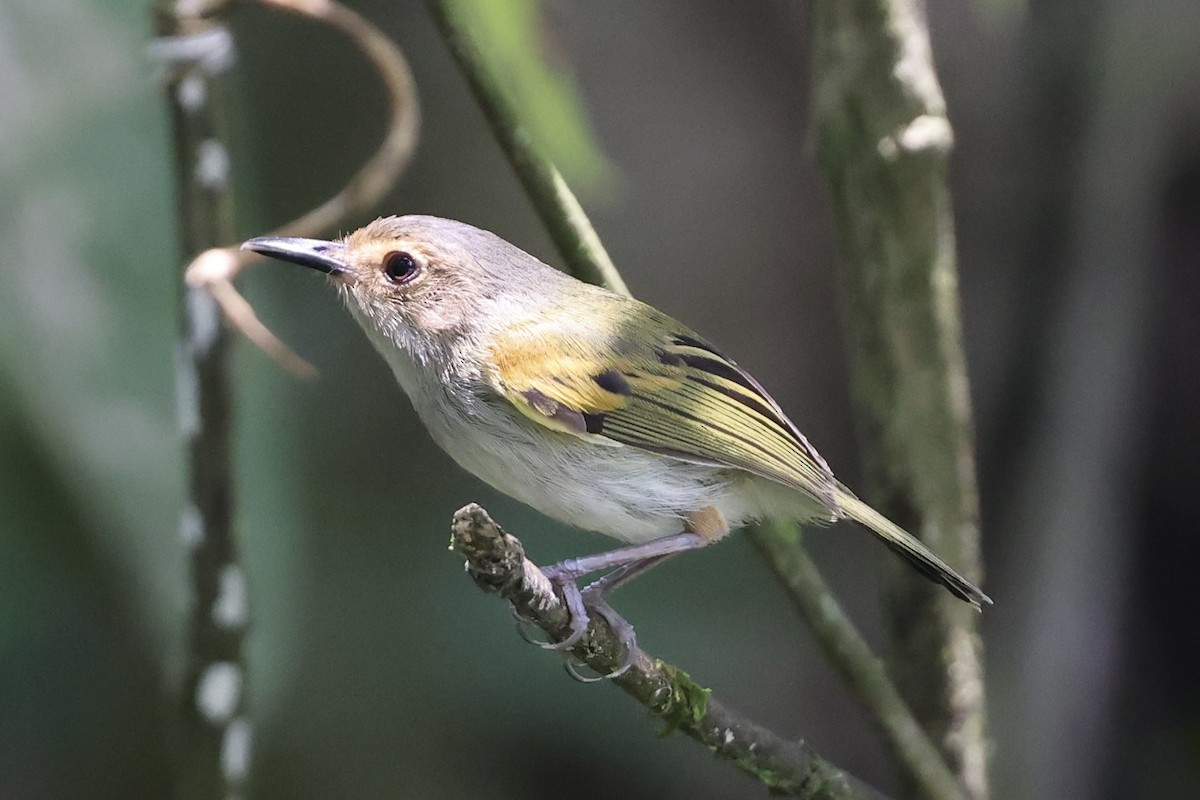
[{"left": 477, "top": 312, "right": 838, "bottom": 511}]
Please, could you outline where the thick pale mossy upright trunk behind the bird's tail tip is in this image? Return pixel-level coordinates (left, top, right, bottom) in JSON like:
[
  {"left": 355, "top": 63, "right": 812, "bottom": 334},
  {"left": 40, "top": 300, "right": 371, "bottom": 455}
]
[{"left": 812, "top": 0, "right": 989, "bottom": 800}]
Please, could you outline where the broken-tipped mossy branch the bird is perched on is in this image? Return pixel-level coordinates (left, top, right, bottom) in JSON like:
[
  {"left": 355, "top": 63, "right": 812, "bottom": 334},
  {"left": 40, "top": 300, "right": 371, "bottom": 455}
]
[{"left": 450, "top": 504, "right": 881, "bottom": 800}]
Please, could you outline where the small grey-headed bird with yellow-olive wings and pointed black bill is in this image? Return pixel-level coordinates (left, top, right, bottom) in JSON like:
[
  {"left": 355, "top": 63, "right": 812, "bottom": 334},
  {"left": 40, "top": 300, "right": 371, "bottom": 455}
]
[{"left": 242, "top": 216, "right": 991, "bottom": 674}]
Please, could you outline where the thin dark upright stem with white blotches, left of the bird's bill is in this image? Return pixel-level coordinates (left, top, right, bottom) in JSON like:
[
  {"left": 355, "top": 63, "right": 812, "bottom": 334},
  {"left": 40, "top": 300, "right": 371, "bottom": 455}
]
[{"left": 154, "top": 4, "right": 250, "bottom": 800}]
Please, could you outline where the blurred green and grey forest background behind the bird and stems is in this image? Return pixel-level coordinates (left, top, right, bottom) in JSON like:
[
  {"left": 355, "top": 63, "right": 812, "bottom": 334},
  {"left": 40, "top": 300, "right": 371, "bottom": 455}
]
[{"left": 0, "top": 0, "right": 1200, "bottom": 800}]
